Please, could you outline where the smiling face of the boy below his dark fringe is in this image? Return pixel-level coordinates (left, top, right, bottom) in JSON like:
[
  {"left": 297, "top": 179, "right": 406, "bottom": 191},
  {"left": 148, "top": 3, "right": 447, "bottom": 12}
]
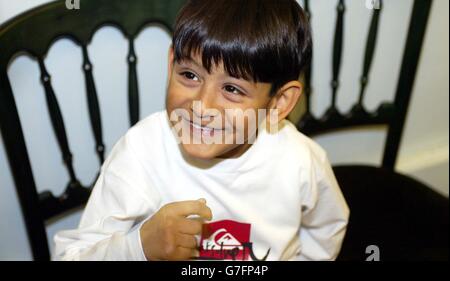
[{"left": 166, "top": 48, "right": 272, "bottom": 159}]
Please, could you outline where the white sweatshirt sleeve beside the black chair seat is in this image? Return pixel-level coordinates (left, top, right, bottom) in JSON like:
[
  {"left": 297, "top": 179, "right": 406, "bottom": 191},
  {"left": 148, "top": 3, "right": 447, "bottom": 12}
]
[{"left": 299, "top": 146, "right": 350, "bottom": 260}]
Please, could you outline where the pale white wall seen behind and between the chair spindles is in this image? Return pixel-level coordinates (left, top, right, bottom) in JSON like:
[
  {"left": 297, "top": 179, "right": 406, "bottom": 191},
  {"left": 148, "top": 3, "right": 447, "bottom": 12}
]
[{"left": 0, "top": 0, "right": 449, "bottom": 260}]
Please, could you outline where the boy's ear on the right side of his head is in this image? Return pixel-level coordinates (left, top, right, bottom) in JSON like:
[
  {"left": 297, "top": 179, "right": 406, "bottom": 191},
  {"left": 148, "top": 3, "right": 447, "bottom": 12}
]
[{"left": 269, "top": 81, "right": 303, "bottom": 121}]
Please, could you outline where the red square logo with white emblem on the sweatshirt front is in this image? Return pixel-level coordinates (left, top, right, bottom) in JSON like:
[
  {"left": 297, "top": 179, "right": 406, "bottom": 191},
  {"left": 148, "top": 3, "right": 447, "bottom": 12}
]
[{"left": 199, "top": 220, "right": 270, "bottom": 260}]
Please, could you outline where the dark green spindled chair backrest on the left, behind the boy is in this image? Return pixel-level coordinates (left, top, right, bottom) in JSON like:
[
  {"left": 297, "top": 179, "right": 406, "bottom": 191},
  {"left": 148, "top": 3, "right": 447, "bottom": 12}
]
[{"left": 0, "top": 0, "right": 185, "bottom": 260}]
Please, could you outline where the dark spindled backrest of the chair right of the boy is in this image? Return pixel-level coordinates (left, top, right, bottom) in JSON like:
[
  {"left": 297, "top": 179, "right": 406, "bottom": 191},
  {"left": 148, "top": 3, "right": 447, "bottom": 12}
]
[{"left": 297, "top": 0, "right": 432, "bottom": 170}]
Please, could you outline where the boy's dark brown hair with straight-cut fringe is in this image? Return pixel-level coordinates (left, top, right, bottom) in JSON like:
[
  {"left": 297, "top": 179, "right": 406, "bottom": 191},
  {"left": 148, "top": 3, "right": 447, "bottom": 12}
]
[{"left": 172, "top": 0, "right": 312, "bottom": 96}]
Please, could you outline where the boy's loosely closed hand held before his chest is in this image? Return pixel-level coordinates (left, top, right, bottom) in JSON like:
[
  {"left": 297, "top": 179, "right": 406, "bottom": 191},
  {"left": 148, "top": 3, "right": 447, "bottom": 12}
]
[{"left": 140, "top": 199, "right": 212, "bottom": 260}]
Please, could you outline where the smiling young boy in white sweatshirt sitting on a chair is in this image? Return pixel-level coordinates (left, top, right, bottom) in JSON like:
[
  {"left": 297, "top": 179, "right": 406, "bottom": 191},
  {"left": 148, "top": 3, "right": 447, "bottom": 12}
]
[{"left": 55, "top": 0, "right": 349, "bottom": 260}]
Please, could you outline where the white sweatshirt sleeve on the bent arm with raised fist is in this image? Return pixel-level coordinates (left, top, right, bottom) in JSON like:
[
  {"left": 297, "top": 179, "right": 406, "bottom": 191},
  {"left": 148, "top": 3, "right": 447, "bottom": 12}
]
[{"left": 53, "top": 131, "right": 159, "bottom": 260}]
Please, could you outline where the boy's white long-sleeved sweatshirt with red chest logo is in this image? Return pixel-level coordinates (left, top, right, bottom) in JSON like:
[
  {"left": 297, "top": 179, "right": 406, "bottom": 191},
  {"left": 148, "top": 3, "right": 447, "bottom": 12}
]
[{"left": 54, "top": 110, "right": 349, "bottom": 260}]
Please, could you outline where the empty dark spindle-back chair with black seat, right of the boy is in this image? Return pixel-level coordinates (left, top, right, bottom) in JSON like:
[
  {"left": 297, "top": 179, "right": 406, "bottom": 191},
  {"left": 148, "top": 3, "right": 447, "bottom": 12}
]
[{"left": 297, "top": 0, "right": 449, "bottom": 260}]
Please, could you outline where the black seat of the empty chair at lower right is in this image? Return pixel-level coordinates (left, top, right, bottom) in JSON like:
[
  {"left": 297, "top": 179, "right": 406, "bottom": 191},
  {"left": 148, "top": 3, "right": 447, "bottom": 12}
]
[{"left": 333, "top": 165, "right": 449, "bottom": 261}]
